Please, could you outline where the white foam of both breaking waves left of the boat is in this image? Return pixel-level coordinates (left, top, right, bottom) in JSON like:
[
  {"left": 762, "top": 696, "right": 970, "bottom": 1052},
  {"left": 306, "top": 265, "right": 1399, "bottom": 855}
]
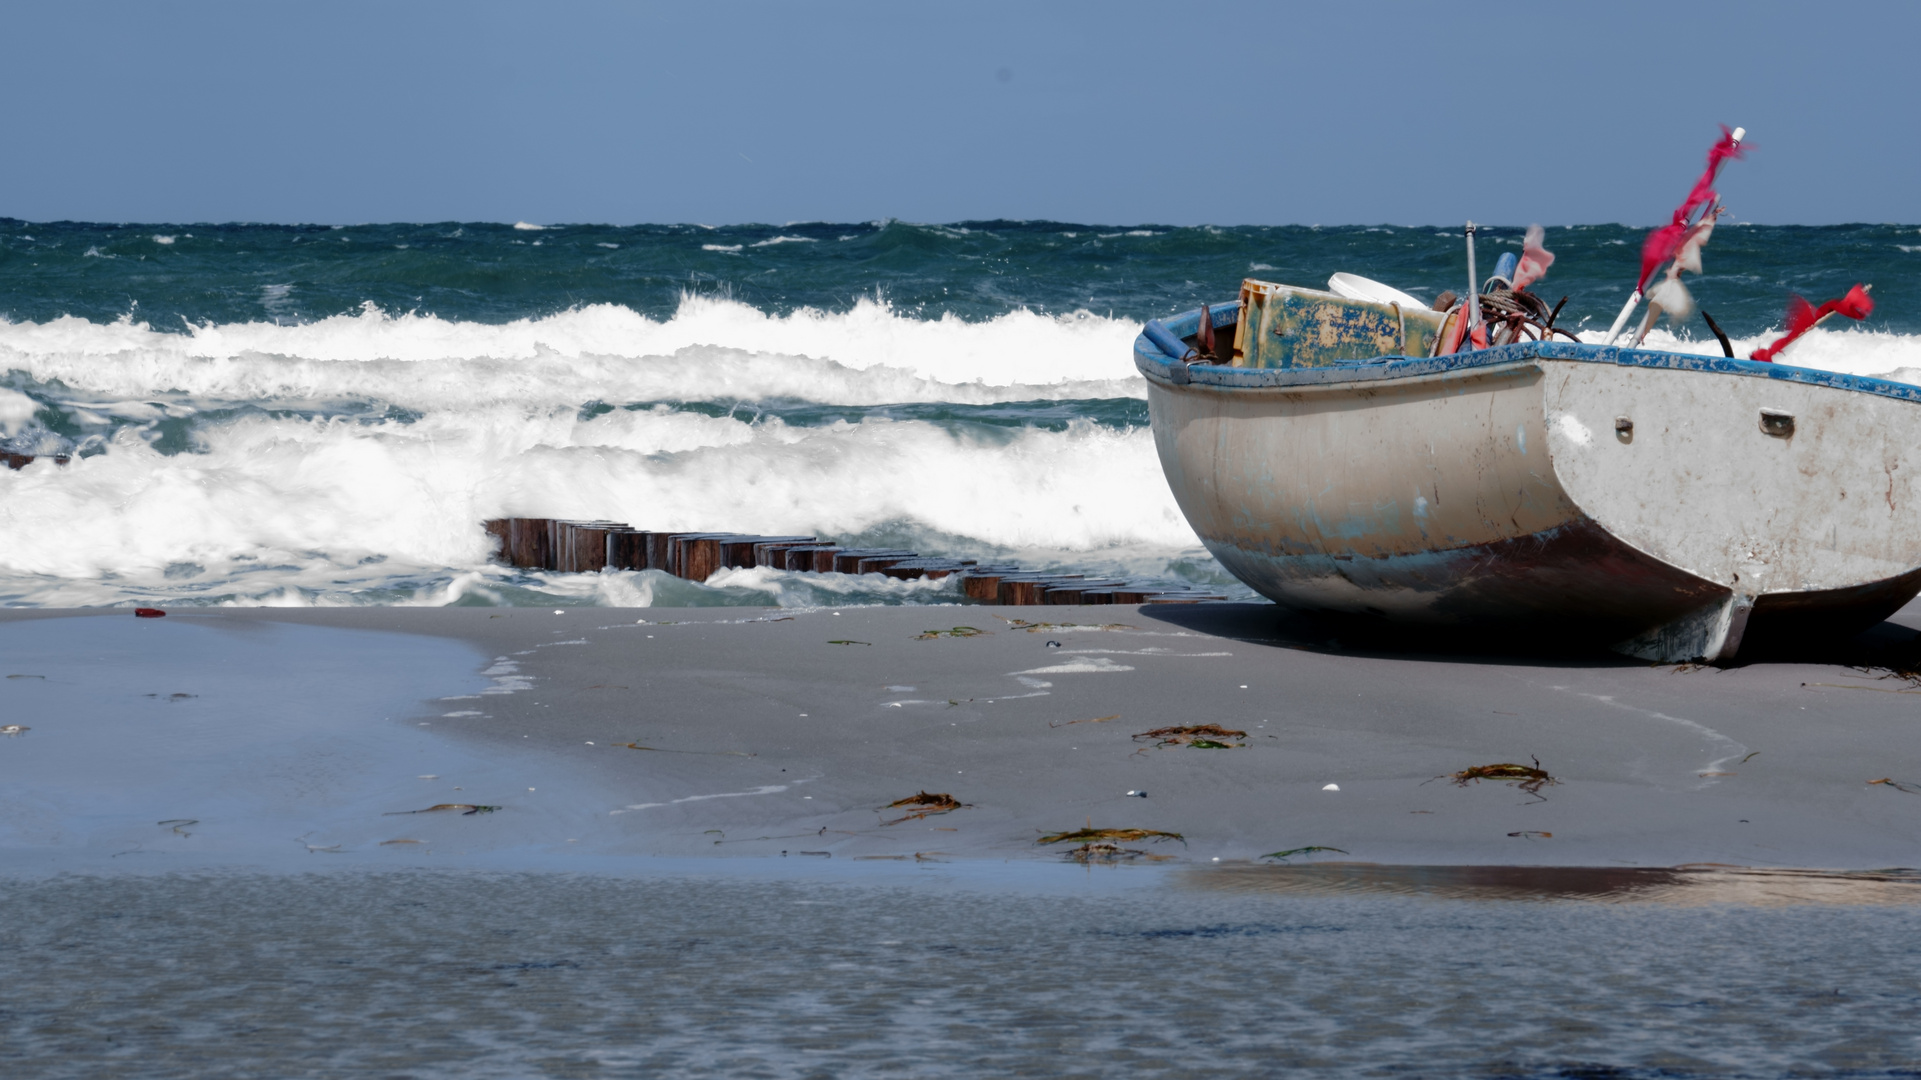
[{"left": 0, "top": 294, "right": 1195, "bottom": 605}]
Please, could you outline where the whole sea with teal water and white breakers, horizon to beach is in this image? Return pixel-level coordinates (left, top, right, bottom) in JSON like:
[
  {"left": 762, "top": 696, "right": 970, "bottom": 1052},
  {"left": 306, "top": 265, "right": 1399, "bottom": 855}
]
[{"left": 0, "top": 219, "right": 1921, "bottom": 607}]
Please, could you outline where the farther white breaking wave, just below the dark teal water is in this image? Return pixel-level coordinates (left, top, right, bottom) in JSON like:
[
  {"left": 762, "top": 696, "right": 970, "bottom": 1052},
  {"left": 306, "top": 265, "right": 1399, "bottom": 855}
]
[{"left": 0, "top": 296, "right": 1143, "bottom": 402}]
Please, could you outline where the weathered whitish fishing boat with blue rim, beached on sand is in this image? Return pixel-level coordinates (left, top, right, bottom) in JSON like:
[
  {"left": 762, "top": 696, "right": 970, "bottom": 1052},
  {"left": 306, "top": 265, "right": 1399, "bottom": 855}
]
[{"left": 1133, "top": 282, "right": 1921, "bottom": 663}]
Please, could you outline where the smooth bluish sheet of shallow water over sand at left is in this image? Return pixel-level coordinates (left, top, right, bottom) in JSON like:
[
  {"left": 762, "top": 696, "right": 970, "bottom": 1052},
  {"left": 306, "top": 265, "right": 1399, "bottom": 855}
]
[{"left": 0, "top": 615, "right": 637, "bottom": 872}]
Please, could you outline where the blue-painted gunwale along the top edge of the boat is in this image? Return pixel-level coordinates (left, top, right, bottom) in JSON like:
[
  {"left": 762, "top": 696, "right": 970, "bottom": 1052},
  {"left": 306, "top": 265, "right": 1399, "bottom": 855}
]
[{"left": 1133, "top": 300, "right": 1921, "bottom": 402}]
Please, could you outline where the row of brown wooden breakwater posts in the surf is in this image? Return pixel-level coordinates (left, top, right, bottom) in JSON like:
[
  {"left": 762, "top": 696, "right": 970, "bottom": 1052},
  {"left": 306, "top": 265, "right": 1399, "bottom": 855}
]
[{"left": 484, "top": 517, "right": 1226, "bottom": 603}]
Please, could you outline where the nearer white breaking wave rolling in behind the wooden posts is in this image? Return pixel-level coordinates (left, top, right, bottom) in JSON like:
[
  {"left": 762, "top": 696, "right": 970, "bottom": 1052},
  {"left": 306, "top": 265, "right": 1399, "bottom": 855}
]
[{"left": 0, "top": 407, "right": 1197, "bottom": 603}]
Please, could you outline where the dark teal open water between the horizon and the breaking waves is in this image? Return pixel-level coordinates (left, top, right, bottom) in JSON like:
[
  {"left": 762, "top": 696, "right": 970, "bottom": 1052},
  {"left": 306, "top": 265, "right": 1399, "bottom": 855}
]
[{"left": 0, "top": 219, "right": 1921, "bottom": 336}]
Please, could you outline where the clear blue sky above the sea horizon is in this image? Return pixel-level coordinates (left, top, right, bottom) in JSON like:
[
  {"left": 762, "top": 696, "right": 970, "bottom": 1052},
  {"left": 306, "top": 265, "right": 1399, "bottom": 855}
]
[{"left": 0, "top": 0, "right": 1921, "bottom": 225}]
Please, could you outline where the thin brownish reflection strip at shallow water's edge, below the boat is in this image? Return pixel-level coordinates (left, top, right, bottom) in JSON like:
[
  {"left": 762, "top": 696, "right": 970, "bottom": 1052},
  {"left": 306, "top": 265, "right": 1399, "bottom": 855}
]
[{"left": 1179, "top": 863, "right": 1921, "bottom": 907}]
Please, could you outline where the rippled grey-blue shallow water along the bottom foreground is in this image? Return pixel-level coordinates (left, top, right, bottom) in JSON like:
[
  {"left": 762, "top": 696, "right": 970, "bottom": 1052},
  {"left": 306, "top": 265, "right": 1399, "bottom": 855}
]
[{"left": 0, "top": 863, "right": 1921, "bottom": 1078}]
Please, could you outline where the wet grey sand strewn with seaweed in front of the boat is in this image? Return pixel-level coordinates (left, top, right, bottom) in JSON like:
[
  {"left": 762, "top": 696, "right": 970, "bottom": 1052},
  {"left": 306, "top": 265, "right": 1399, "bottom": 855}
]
[{"left": 0, "top": 603, "right": 1921, "bottom": 869}]
